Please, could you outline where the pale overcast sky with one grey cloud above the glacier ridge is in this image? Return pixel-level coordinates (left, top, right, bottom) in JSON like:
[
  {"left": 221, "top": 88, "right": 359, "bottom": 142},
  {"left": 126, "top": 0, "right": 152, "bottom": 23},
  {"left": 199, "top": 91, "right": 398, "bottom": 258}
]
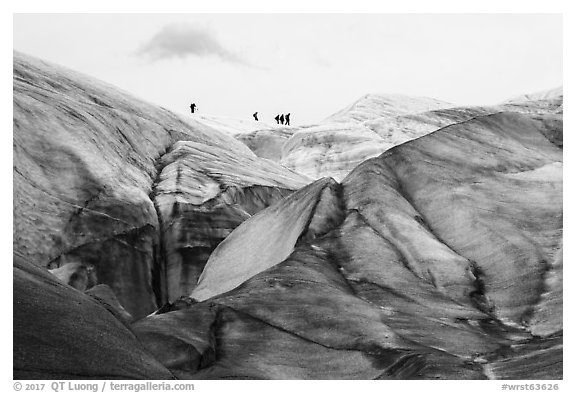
[{"left": 13, "top": 13, "right": 563, "bottom": 125}]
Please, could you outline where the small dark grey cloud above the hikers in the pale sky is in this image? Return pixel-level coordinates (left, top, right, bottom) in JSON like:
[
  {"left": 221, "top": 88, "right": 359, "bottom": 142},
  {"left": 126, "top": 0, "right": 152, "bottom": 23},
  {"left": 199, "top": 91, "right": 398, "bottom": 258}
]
[{"left": 136, "top": 25, "right": 248, "bottom": 65}]
